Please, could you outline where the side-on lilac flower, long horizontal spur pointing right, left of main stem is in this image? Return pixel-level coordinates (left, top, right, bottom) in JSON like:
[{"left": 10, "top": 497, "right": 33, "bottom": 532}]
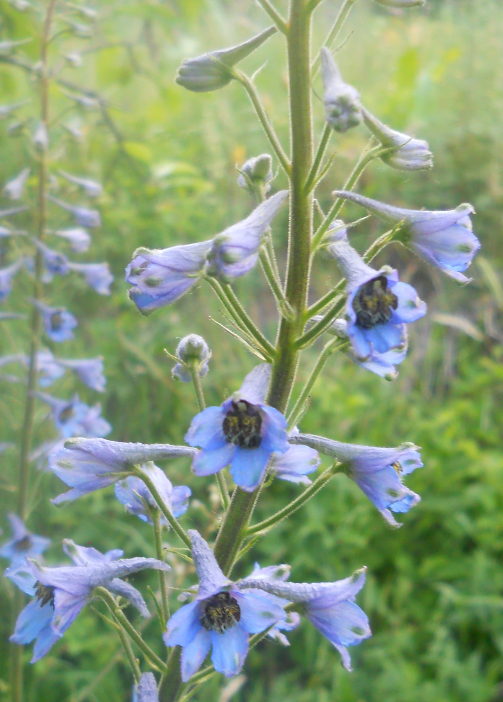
[{"left": 49, "top": 438, "right": 196, "bottom": 504}]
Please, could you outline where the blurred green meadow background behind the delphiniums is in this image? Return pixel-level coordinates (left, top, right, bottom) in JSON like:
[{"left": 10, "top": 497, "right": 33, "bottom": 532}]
[{"left": 0, "top": 0, "right": 503, "bottom": 702}]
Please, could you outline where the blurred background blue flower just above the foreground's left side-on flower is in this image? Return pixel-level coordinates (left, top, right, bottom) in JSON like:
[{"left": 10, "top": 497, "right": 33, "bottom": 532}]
[{"left": 37, "top": 392, "right": 112, "bottom": 439}]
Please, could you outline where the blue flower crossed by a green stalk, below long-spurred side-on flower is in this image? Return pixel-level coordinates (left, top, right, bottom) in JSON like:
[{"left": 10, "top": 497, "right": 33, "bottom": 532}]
[{"left": 115, "top": 461, "right": 192, "bottom": 527}]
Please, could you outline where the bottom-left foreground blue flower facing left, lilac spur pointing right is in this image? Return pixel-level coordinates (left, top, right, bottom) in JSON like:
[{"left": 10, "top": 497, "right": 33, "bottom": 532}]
[{"left": 6, "top": 541, "right": 170, "bottom": 663}]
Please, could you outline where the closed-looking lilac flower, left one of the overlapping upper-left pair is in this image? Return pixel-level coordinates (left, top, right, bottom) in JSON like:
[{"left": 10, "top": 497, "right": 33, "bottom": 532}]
[{"left": 126, "top": 240, "right": 212, "bottom": 314}]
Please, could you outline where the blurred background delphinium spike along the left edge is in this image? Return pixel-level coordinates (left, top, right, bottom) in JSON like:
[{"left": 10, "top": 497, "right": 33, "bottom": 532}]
[{"left": 0, "top": 0, "right": 113, "bottom": 702}]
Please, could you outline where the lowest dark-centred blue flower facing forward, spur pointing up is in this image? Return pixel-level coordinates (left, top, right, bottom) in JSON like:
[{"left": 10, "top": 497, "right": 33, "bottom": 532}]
[{"left": 163, "top": 530, "right": 286, "bottom": 682}]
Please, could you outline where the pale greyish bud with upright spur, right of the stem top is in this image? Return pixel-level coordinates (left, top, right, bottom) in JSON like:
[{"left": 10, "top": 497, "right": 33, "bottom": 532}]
[{"left": 321, "top": 47, "right": 363, "bottom": 132}]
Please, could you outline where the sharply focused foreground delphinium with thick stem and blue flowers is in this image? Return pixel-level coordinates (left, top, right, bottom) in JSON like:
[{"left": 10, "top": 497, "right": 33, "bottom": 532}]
[{"left": 5, "top": 0, "right": 479, "bottom": 702}]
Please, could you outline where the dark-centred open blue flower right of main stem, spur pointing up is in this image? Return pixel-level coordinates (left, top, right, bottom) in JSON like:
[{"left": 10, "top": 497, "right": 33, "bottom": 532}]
[{"left": 327, "top": 237, "right": 426, "bottom": 361}]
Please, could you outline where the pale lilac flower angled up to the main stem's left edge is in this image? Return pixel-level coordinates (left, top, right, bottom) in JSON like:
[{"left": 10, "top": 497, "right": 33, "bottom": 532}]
[{"left": 207, "top": 190, "right": 288, "bottom": 282}]
